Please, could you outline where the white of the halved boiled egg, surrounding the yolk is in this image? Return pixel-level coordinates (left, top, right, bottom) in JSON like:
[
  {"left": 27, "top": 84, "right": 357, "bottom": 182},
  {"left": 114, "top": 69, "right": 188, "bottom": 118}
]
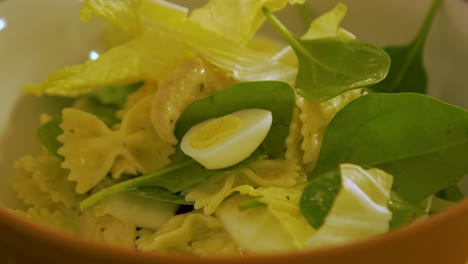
[{"left": 180, "top": 109, "right": 273, "bottom": 169}]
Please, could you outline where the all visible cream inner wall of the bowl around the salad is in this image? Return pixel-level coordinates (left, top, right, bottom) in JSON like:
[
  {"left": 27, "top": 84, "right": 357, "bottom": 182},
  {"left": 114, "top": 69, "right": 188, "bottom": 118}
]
[{"left": 0, "top": 0, "right": 468, "bottom": 253}]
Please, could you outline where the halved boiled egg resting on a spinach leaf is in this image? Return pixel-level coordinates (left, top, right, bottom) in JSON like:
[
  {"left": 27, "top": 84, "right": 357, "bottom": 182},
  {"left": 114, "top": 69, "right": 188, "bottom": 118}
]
[{"left": 180, "top": 109, "right": 273, "bottom": 169}]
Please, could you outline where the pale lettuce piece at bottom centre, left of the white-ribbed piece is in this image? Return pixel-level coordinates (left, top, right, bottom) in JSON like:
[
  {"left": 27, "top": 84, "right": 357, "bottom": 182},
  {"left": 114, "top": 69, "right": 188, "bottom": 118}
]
[{"left": 215, "top": 189, "right": 315, "bottom": 253}]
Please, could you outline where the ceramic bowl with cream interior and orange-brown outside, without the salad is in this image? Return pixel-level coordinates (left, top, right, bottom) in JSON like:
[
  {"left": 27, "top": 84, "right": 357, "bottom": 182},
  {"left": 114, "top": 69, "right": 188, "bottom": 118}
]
[{"left": 0, "top": 0, "right": 468, "bottom": 264}]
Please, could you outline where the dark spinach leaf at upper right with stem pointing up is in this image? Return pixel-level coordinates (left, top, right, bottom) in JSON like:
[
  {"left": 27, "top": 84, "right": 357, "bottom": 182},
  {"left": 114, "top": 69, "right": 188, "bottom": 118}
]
[{"left": 373, "top": 0, "right": 442, "bottom": 93}]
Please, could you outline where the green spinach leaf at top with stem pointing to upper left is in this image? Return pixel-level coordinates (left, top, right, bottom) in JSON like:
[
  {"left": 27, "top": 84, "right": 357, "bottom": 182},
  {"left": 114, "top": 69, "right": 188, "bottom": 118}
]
[{"left": 263, "top": 8, "right": 390, "bottom": 101}]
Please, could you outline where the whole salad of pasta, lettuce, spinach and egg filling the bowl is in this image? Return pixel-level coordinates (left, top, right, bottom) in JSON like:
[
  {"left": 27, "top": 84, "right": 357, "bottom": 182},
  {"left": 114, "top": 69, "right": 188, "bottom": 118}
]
[{"left": 12, "top": 0, "right": 468, "bottom": 256}]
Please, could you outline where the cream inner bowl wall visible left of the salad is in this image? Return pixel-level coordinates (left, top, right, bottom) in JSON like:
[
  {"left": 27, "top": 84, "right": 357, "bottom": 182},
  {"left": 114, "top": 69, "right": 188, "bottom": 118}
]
[{"left": 0, "top": 0, "right": 107, "bottom": 206}]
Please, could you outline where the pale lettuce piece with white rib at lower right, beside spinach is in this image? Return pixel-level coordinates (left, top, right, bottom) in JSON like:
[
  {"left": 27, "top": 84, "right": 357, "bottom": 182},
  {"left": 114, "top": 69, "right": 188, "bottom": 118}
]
[{"left": 306, "top": 164, "right": 393, "bottom": 248}]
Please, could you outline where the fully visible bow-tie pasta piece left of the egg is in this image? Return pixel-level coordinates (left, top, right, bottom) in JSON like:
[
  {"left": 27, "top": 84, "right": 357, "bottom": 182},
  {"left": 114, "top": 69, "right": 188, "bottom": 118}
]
[{"left": 58, "top": 96, "right": 174, "bottom": 193}]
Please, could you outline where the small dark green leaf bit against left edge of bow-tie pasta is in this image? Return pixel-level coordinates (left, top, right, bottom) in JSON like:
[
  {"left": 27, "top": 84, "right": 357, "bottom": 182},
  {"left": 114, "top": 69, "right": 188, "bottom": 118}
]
[{"left": 36, "top": 116, "right": 63, "bottom": 160}]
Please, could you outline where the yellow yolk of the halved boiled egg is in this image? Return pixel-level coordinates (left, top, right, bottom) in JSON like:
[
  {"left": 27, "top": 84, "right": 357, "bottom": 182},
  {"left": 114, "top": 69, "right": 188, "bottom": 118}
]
[{"left": 190, "top": 115, "right": 244, "bottom": 149}]
